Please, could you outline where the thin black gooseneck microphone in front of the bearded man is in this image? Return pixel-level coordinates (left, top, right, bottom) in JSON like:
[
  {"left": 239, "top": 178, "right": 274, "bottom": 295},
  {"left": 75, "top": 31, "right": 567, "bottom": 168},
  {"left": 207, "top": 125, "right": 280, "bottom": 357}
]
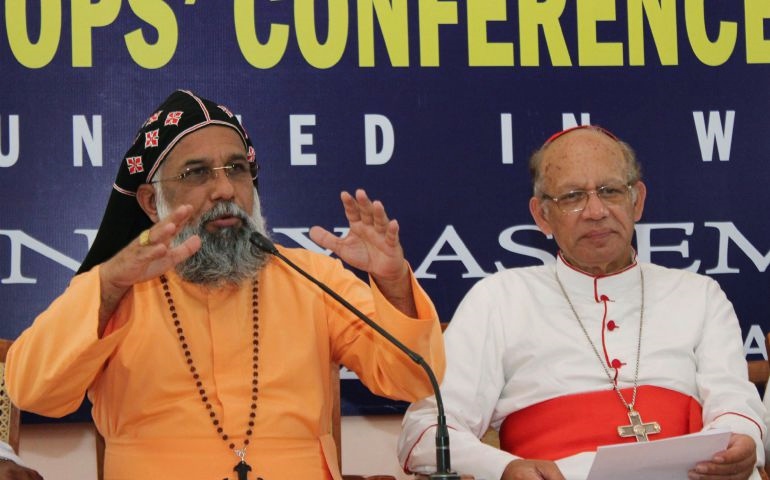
[{"left": 249, "top": 232, "right": 460, "bottom": 480}]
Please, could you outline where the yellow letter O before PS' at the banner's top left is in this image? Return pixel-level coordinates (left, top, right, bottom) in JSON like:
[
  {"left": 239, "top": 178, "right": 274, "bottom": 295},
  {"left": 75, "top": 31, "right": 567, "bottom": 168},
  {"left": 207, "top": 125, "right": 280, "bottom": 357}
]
[{"left": 5, "top": 1, "right": 61, "bottom": 68}]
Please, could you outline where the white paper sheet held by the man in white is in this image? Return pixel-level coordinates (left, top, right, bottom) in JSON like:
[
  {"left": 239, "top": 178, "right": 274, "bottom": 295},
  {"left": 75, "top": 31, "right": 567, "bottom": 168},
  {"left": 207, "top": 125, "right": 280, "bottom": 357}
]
[{"left": 586, "top": 429, "right": 730, "bottom": 480}]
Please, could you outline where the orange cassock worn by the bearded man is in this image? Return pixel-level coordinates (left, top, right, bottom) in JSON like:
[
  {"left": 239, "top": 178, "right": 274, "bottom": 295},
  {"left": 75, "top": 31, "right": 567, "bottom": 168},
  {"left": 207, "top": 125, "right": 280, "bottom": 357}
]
[{"left": 6, "top": 247, "right": 445, "bottom": 480}]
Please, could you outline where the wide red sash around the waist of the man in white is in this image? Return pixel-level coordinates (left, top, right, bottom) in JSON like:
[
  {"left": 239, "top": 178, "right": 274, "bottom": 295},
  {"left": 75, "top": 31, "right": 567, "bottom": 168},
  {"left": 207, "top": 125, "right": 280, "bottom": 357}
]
[{"left": 500, "top": 386, "right": 703, "bottom": 460}]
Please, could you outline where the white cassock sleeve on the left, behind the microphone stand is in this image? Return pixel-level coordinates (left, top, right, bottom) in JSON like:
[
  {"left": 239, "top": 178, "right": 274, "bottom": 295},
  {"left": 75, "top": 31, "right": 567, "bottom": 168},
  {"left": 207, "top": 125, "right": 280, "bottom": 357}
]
[{"left": 398, "top": 280, "right": 518, "bottom": 480}]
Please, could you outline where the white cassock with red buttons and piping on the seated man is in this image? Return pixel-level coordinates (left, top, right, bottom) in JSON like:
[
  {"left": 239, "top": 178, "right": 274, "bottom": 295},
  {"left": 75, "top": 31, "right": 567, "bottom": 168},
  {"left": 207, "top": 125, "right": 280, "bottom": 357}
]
[{"left": 399, "top": 256, "right": 766, "bottom": 480}]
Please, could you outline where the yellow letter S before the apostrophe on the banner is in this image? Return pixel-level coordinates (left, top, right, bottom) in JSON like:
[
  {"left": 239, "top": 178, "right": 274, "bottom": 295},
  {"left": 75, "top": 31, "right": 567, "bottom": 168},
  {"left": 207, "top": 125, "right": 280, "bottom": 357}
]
[{"left": 125, "top": 0, "right": 179, "bottom": 68}]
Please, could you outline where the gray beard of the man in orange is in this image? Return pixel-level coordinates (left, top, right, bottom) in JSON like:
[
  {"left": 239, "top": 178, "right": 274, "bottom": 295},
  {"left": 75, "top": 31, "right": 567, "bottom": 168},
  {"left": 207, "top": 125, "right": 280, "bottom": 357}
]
[{"left": 158, "top": 188, "right": 269, "bottom": 287}]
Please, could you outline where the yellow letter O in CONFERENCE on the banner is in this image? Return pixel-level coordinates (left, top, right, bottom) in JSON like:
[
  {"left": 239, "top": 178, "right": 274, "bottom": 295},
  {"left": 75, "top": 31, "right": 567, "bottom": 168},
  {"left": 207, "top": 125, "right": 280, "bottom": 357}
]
[{"left": 294, "top": 0, "right": 348, "bottom": 68}]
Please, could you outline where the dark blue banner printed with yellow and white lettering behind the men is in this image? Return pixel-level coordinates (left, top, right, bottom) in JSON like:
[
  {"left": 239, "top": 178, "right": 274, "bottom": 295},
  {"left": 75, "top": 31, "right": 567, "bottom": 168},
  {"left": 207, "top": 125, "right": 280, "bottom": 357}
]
[{"left": 0, "top": 0, "right": 770, "bottom": 414}]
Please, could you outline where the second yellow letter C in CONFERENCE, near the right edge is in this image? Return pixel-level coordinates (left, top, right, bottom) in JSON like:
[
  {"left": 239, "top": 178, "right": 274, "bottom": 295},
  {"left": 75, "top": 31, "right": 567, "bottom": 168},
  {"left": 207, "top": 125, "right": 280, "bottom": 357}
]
[{"left": 684, "top": 0, "right": 738, "bottom": 67}]
